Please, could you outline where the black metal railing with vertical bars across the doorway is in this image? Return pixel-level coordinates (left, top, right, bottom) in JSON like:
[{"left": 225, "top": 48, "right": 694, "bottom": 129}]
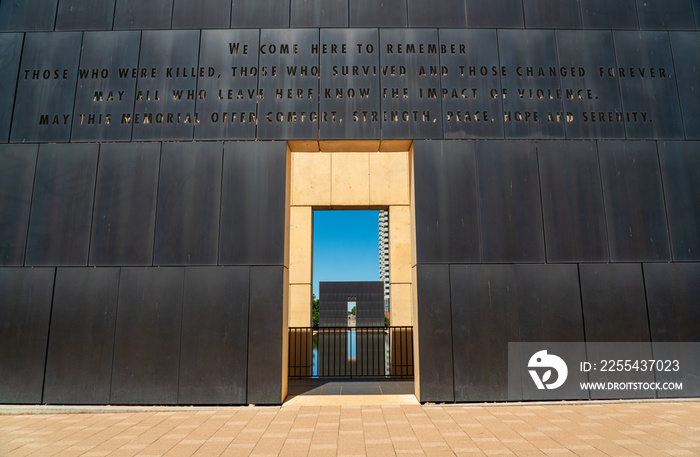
[{"left": 289, "top": 327, "right": 413, "bottom": 378}]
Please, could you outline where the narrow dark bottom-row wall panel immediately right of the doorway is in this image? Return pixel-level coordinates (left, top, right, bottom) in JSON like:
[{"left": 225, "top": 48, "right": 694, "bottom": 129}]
[{"left": 413, "top": 264, "right": 455, "bottom": 402}]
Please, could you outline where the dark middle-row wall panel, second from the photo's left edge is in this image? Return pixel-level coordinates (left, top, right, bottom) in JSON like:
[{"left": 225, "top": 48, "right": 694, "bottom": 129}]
[{"left": 25, "top": 144, "right": 98, "bottom": 265}]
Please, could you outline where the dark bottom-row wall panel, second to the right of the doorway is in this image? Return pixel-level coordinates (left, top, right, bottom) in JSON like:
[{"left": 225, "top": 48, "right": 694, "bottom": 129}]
[{"left": 452, "top": 265, "right": 519, "bottom": 402}]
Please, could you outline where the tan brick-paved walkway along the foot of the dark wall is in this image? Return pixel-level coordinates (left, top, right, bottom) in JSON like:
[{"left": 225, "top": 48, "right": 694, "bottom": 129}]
[{"left": 0, "top": 396, "right": 700, "bottom": 457}]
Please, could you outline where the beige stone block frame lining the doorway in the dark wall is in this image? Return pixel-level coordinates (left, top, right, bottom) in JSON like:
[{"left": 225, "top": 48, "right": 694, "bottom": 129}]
[{"left": 285, "top": 140, "right": 417, "bottom": 394}]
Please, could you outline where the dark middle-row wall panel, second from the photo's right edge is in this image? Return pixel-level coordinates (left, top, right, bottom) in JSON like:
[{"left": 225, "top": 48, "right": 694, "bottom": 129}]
[{"left": 598, "top": 141, "right": 671, "bottom": 262}]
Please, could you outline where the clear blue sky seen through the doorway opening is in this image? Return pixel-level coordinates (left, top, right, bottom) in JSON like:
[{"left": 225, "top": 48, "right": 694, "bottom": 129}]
[{"left": 313, "top": 211, "right": 379, "bottom": 297}]
